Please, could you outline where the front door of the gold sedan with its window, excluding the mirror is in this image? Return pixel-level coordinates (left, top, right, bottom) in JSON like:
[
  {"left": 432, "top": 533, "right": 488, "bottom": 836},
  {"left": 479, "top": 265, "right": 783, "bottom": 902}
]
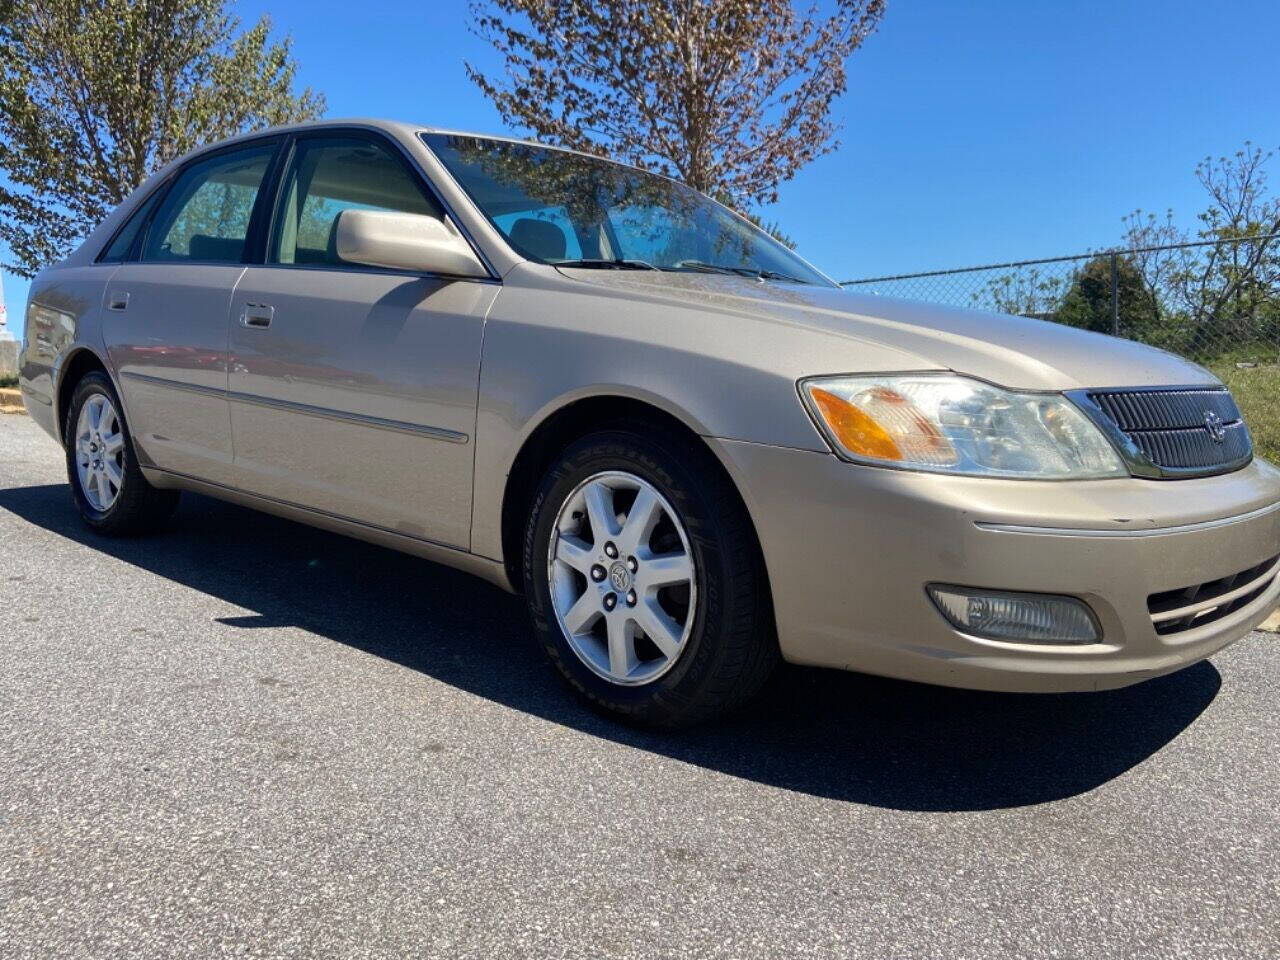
[{"left": 228, "top": 131, "right": 499, "bottom": 547}]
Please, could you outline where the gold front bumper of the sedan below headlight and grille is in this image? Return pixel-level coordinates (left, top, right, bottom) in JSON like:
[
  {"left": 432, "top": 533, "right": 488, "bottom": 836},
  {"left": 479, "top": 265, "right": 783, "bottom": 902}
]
[{"left": 710, "top": 440, "right": 1280, "bottom": 691}]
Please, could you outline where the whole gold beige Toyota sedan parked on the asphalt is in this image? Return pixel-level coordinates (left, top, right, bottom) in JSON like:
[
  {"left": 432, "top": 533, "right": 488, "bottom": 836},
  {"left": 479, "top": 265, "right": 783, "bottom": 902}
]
[{"left": 20, "top": 120, "right": 1280, "bottom": 726}]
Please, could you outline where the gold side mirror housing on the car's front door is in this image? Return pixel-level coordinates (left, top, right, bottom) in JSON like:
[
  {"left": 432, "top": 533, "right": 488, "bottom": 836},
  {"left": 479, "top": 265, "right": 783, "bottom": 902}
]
[{"left": 334, "top": 210, "right": 489, "bottom": 276}]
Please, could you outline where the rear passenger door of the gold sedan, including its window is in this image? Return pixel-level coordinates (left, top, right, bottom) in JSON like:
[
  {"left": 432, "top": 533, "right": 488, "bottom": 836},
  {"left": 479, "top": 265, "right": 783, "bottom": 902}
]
[{"left": 102, "top": 138, "right": 280, "bottom": 484}]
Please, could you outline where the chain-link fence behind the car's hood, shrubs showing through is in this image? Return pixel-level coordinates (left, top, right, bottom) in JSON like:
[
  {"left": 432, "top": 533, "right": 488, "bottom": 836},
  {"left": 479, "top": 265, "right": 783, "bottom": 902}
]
[{"left": 842, "top": 233, "right": 1280, "bottom": 460}]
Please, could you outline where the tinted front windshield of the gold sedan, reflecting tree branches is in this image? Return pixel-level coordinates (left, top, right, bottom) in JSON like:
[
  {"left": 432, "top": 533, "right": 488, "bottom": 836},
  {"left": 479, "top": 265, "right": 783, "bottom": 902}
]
[{"left": 422, "top": 133, "right": 832, "bottom": 287}]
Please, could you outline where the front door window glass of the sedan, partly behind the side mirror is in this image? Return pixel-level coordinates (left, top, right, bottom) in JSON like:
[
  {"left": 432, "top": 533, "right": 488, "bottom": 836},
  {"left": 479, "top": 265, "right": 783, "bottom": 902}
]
[{"left": 268, "top": 137, "right": 444, "bottom": 266}]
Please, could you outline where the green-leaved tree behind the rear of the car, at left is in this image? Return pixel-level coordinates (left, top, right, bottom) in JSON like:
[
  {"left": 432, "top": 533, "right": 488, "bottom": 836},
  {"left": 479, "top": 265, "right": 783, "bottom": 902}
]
[{"left": 0, "top": 0, "right": 324, "bottom": 276}]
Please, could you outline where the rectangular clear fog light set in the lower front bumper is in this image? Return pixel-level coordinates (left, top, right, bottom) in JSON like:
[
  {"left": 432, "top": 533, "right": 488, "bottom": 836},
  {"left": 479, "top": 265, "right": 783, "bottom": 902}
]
[{"left": 929, "top": 584, "right": 1102, "bottom": 644}]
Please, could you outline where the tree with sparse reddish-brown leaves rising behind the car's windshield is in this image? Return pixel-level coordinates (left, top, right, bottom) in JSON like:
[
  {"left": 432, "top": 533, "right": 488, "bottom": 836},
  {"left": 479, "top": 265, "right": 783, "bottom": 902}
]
[{"left": 466, "top": 0, "right": 884, "bottom": 207}]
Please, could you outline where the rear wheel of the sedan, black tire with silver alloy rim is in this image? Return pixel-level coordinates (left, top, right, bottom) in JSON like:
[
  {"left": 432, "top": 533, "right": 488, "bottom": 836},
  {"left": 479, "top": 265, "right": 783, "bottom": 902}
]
[{"left": 63, "top": 371, "right": 178, "bottom": 536}]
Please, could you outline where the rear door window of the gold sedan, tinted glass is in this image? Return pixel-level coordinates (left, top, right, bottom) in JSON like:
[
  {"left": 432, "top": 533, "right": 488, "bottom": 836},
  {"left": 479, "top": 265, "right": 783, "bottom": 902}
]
[{"left": 142, "top": 143, "right": 275, "bottom": 264}]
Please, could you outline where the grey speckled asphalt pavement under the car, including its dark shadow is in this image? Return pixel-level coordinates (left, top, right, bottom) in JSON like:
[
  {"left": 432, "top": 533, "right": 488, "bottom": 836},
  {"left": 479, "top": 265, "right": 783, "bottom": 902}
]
[{"left": 0, "top": 417, "right": 1280, "bottom": 960}]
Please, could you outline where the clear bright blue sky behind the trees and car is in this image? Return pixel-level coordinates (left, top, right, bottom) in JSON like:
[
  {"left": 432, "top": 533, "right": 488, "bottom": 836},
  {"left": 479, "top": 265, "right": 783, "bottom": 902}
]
[{"left": 5, "top": 0, "right": 1280, "bottom": 337}]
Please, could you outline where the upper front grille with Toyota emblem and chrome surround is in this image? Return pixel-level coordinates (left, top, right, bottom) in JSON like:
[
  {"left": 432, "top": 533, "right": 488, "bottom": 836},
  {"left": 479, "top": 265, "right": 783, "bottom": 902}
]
[{"left": 1085, "top": 387, "right": 1253, "bottom": 476}]
